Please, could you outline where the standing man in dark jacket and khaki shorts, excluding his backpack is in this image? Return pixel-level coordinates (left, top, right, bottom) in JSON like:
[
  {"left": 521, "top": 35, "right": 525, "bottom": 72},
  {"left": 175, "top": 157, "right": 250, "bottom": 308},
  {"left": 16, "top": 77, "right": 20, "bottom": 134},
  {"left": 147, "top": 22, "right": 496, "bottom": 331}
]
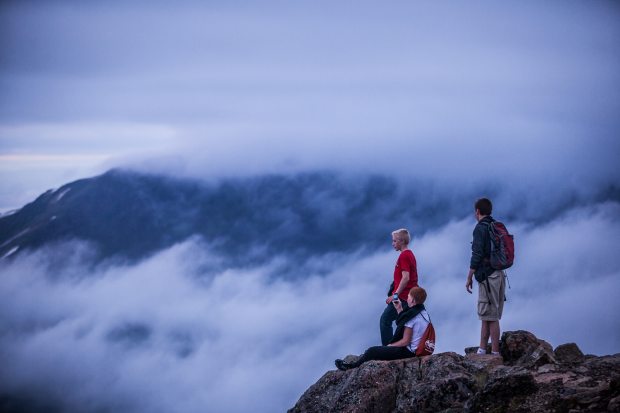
[{"left": 465, "top": 198, "right": 506, "bottom": 354}]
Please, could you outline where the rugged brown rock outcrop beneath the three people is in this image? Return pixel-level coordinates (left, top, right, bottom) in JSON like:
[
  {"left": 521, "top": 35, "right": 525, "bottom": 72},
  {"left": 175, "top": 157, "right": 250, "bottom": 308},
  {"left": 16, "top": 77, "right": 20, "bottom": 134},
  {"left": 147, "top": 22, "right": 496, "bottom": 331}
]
[{"left": 289, "top": 331, "right": 620, "bottom": 413}]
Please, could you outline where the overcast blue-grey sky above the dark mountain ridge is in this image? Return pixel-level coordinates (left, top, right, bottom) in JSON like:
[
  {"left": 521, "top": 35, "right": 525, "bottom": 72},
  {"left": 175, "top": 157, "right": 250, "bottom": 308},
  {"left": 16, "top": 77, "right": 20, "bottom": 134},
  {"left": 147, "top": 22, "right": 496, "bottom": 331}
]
[{"left": 0, "top": 1, "right": 620, "bottom": 211}]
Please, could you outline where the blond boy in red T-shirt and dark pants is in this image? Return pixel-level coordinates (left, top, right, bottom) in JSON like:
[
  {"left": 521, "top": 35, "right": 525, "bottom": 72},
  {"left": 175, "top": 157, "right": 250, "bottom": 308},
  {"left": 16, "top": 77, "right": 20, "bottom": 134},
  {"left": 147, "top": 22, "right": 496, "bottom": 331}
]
[{"left": 379, "top": 229, "right": 418, "bottom": 346}]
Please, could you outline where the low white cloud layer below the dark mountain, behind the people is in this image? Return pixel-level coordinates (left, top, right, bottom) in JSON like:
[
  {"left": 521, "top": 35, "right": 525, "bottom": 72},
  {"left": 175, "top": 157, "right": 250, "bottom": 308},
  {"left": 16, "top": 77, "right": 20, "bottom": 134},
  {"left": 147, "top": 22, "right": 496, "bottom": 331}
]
[{"left": 0, "top": 198, "right": 620, "bottom": 412}]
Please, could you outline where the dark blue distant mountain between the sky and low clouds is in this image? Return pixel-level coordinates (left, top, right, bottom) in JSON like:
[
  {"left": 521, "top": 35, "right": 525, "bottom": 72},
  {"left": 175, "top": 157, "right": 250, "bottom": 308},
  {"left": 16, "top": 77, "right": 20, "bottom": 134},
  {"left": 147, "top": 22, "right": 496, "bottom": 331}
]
[{"left": 0, "top": 170, "right": 620, "bottom": 266}]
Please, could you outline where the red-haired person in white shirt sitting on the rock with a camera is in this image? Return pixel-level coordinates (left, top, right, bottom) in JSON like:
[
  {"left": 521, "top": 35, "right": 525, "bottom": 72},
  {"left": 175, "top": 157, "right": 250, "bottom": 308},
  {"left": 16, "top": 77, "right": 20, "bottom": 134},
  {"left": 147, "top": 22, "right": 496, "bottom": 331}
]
[{"left": 336, "top": 287, "right": 430, "bottom": 370}]
